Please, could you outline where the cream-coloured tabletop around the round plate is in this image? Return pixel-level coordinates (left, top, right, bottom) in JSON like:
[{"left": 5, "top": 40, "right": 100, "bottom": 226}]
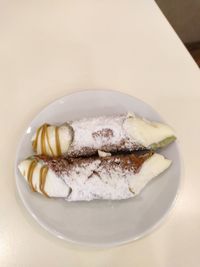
[{"left": 0, "top": 0, "right": 200, "bottom": 267}]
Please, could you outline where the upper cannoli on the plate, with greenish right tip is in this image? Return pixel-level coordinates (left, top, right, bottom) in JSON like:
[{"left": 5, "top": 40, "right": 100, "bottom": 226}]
[{"left": 32, "top": 113, "right": 175, "bottom": 157}]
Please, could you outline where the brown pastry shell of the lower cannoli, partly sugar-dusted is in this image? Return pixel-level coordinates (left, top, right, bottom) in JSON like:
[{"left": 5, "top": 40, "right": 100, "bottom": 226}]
[{"left": 37, "top": 152, "right": 152, "bottom": 201}]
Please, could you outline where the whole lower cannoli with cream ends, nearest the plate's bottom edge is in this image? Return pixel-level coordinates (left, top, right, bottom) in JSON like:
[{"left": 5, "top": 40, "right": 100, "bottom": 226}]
[{"left": 18, "top": 151, "right": 171, "bottom": 201}]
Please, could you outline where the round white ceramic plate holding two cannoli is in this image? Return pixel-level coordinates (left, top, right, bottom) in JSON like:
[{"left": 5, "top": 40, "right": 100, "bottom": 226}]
[{"left": 15, "top": 90, "right": 180, "bottom": 247}]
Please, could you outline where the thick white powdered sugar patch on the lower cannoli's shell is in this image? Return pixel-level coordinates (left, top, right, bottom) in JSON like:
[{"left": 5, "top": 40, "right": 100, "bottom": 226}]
[{"left": 62, "top": 160, "right": 134, "bottom": 201}]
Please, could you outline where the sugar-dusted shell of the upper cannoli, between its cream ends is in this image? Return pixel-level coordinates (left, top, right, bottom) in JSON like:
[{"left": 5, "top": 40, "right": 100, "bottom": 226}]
[{"left": 67, "top": 115, "right": 141, "bottom": 156}]
